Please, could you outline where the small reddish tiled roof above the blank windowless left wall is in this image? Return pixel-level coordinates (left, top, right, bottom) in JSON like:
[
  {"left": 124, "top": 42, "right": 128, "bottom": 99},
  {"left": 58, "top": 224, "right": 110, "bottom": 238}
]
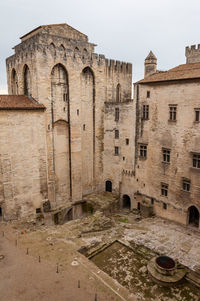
[{"left": 0, "top": 95, "right": 45, "bottom": 110}]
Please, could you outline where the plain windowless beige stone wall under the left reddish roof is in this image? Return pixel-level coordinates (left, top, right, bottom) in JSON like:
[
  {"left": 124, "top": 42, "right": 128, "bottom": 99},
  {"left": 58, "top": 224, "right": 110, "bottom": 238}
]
[{"left": 0, "top": 110, "right": 48, "bottom": 220}]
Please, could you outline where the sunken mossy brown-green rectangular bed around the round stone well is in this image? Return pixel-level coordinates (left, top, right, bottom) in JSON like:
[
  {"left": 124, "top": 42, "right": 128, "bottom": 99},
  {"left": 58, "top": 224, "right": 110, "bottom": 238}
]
[{"left": 90, "top": 241, "right": 200, "bottom": 301}]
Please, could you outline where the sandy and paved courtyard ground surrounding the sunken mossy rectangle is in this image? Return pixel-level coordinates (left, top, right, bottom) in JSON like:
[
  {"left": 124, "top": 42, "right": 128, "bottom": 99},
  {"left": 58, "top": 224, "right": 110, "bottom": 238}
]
[{"left": 0, "top": 212, "right": 200, "bottom": 301}]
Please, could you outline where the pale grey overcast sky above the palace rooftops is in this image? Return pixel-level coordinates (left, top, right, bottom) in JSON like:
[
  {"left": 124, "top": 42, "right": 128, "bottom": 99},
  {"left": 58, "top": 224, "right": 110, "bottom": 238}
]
[{"left": 0, "top": 0, "right": 200, "bottom": 93}]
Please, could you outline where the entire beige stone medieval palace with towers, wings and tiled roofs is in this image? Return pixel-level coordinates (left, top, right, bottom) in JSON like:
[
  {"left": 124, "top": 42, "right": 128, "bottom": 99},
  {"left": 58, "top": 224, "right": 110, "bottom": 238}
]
[{"left": 0, "top": 24, "right": 200, "bottom": 228}]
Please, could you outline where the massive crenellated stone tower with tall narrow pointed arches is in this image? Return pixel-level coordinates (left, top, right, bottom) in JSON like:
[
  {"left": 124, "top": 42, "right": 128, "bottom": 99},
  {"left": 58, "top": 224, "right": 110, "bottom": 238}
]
[{"left": 6, "top": 23, "right": 132, "bottom": 209}]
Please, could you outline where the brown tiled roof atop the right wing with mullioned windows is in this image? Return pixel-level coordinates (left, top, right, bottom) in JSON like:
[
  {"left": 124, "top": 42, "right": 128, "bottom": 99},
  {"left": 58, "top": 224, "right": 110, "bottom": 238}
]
[{"left": 137, "top": 63, "right": 200, "bottom": 84}]
